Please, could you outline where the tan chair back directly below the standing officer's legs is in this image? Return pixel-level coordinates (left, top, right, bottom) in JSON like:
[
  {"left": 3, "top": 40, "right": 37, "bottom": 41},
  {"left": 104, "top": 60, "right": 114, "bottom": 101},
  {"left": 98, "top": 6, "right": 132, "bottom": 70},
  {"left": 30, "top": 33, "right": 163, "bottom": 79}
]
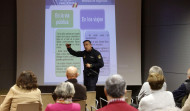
[{"left": 86, "top": 91, "right": 96, "bottom": 110}]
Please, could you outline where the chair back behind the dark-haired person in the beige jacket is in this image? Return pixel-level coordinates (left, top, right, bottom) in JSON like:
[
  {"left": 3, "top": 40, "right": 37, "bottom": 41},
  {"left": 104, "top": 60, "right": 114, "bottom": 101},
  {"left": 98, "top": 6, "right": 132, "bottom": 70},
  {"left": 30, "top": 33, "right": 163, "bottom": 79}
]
[{"left": 16, "top": 103, "right": 40, "bottom": 111}]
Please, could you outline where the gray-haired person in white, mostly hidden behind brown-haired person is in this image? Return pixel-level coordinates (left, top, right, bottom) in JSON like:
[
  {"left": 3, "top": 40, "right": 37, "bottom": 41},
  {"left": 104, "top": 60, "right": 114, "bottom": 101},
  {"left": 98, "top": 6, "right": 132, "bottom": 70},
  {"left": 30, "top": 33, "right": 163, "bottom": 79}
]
[{"left": 138, "top": 66, "right": 166, "bottom": 101}]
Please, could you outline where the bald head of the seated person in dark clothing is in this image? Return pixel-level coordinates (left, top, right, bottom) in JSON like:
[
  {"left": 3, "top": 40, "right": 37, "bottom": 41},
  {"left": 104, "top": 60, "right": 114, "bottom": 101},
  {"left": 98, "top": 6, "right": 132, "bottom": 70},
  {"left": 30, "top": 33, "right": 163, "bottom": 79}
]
[{"left": 66, "top": 66, "right": 79, "bottom": 79}]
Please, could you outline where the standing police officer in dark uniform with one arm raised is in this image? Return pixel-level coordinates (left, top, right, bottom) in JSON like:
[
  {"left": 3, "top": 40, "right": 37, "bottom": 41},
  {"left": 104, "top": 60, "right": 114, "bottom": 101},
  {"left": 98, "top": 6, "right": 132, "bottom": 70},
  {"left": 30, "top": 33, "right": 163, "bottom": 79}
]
[{"left": 66, "top": 40, "right": 104, "bottom": 91}]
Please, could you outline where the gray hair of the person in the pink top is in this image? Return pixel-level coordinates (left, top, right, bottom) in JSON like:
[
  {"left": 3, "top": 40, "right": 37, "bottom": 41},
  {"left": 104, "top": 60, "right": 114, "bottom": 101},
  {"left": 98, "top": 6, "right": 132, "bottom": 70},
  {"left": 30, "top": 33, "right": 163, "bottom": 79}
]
[{"left": 54, "top": 82, "right": 75, "bottom": 99}]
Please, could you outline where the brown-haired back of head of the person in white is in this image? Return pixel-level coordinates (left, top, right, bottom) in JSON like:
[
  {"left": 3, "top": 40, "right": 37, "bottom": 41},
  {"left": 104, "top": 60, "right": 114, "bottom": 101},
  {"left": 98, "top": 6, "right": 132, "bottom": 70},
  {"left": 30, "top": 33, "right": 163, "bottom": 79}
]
[{"left": 148, "top": 73, "right": 164, "bottom": 90}]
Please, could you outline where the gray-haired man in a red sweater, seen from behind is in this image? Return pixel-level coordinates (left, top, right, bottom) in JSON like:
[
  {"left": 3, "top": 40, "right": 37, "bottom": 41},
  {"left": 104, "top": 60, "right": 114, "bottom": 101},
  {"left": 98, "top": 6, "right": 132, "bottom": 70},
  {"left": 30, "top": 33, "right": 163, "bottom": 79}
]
[{"left": 97, "top": 74, "right": 138, "bottom": 111}]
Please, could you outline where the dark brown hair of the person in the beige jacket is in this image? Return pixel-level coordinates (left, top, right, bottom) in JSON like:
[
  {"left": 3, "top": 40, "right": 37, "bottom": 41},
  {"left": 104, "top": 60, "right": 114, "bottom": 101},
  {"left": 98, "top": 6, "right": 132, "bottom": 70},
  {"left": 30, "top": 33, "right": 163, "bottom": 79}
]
[{"left": 16, "top": 71, "right": 38, "bottom": 90}]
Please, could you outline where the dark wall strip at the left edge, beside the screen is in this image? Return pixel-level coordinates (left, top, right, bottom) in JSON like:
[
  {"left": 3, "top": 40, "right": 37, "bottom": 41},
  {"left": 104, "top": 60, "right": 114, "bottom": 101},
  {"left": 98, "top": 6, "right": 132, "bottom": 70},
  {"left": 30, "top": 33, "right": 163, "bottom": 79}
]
[{"left": 0, "top": 0, "right": 17, "bottom": 91}]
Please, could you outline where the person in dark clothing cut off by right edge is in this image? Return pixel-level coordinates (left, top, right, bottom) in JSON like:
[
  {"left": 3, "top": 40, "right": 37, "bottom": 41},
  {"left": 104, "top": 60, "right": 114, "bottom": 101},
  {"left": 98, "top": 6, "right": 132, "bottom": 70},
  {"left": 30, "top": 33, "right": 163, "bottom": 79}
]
[{"left": 173, "top": 68, "right": 190, "bottom": 108}]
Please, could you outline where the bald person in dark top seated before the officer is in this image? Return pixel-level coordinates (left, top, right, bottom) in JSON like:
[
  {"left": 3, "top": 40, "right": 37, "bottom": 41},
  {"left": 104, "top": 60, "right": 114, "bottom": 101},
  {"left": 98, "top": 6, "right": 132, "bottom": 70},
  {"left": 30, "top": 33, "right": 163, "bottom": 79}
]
[{"left": 52, "top": 66, "right": 86, "bottom": 101}]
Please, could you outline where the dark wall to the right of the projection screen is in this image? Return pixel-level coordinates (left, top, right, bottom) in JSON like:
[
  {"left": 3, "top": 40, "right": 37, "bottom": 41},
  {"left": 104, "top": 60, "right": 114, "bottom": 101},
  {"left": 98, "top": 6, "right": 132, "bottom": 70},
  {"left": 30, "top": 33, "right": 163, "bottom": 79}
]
[{"left": 142, "top": 0, "right": 190, "bottom": 91}]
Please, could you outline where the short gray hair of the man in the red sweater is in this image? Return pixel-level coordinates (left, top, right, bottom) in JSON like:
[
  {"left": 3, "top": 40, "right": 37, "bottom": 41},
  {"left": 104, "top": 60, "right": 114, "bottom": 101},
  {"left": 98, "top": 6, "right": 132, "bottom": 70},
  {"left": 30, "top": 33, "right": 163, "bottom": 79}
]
[{"left": 105, "top": 74, "right": 126, "bottom": 98}]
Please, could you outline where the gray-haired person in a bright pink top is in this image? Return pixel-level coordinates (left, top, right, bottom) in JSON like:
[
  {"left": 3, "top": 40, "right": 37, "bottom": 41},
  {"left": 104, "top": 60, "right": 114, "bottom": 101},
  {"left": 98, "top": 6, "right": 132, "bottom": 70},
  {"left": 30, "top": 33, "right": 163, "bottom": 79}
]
[{"left": 45, "top": 82, "right": 81, "bottom": 111}]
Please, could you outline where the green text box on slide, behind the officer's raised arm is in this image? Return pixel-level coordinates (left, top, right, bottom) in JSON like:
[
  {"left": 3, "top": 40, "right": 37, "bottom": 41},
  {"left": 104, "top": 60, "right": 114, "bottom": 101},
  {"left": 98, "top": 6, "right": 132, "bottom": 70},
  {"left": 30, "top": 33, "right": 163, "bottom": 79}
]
[{"left": 55, "top": 29, "right": 81, "bottom": 77}]
